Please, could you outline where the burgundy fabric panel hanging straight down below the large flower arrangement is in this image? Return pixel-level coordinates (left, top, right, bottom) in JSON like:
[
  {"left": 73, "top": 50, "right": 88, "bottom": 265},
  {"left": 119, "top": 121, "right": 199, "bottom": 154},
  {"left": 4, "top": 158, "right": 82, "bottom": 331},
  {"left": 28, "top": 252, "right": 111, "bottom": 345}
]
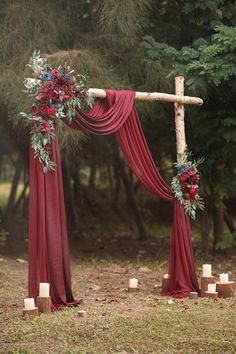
[{"left": 29, "top": 131, "right": 76, "bottom": 308}]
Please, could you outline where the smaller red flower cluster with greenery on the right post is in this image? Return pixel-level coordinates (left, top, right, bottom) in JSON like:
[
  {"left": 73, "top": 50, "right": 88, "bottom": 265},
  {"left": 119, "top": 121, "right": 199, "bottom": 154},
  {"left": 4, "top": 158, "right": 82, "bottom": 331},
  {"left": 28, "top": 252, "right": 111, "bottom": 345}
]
[{"left": 171, "top": 151, "right": 204, "bottom": 219}]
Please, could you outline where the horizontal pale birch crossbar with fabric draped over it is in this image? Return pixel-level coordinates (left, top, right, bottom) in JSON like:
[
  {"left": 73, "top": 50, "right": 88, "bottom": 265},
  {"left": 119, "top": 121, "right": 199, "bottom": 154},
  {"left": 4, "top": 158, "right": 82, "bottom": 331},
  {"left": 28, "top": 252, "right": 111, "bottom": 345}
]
[{"left": 88, "top": 88, "right": 203, "bottom": 106}]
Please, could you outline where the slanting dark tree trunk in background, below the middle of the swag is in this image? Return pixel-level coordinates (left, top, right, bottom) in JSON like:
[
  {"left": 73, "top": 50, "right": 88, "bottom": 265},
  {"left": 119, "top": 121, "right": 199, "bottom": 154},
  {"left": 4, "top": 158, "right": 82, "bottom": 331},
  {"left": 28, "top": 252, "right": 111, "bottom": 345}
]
[{"left": 110, "top": 137, "right": 147, "bottom": 240}]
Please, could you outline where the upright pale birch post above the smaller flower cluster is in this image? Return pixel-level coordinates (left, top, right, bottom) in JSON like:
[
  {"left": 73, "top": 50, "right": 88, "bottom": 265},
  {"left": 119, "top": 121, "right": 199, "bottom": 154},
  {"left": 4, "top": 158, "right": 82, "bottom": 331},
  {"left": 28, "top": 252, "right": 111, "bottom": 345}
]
[{"left": 175, "top": 76, "right": 186, "bottom": 154}]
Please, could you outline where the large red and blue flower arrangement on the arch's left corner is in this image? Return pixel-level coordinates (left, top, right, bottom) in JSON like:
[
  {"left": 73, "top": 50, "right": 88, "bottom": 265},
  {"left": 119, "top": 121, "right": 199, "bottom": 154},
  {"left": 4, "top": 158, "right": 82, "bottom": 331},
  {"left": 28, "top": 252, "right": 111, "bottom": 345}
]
[{"left": 20, "top": 50, "right": 93, "bottom": 173}]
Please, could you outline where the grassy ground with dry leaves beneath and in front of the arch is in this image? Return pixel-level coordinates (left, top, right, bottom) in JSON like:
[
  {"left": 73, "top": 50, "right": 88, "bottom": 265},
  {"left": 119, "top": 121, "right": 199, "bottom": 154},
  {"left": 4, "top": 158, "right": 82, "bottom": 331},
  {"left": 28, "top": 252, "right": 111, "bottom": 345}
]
[{"left": 0, "top": 259, "right": 236, "bottom": 354}]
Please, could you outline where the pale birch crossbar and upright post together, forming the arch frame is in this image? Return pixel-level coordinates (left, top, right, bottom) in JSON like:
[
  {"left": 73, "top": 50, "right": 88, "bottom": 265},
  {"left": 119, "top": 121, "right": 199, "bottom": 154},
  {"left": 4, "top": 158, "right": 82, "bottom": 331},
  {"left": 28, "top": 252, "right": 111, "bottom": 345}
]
[{"left": 88, "top": 76, "right": 203, "bottom": 155}]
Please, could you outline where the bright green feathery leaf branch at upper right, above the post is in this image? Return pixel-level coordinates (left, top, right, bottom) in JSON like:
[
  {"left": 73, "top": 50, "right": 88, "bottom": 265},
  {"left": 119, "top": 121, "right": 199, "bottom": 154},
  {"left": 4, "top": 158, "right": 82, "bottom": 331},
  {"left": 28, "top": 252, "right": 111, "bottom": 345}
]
[{"left": 143, "top": 25, "right": 236, "bottom": 90}]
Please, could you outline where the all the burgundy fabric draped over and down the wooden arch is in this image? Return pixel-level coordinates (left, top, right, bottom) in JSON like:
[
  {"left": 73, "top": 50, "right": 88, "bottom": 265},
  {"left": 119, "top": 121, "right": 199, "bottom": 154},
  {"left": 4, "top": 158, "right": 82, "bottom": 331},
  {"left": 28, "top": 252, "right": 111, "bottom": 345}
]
[{"left": 29, "top": 90, "right": 199, "bottom": 308}]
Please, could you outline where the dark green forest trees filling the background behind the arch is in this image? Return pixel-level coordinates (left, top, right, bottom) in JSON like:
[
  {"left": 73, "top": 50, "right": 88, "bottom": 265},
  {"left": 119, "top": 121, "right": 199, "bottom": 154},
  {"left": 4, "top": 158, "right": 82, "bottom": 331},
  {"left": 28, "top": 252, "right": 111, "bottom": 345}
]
[{"left": 0, "top": 0, "right": 236, "bottom": 252}]
